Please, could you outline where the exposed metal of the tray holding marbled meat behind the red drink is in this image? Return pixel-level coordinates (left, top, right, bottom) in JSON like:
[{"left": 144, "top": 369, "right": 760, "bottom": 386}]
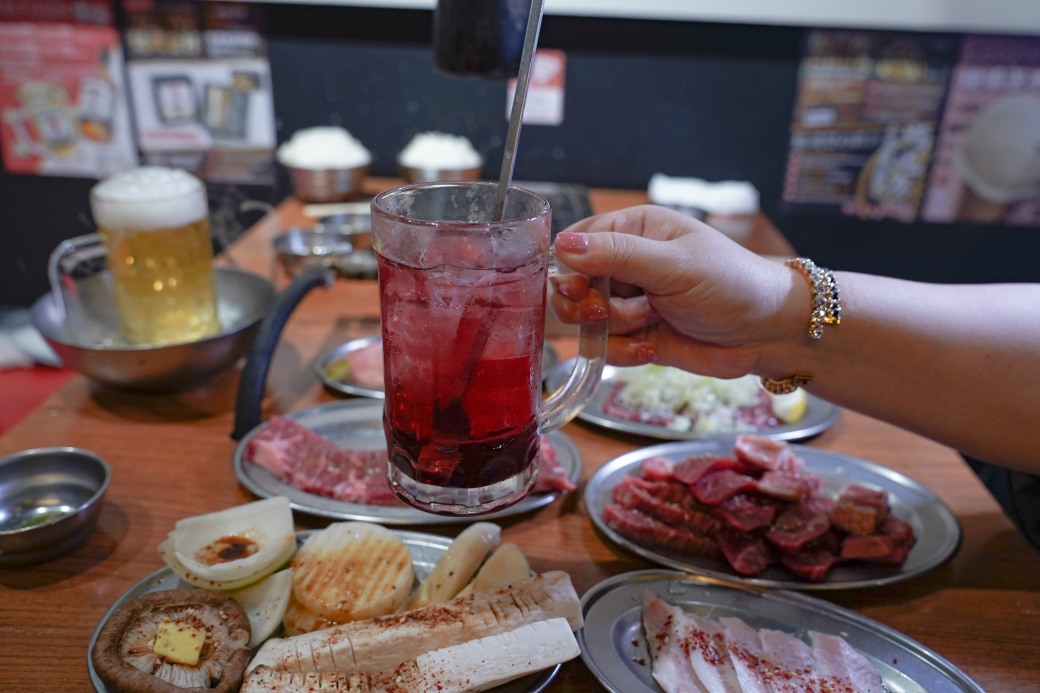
[{"left": 232, "top": 399, "right": 583, "bottom": 525}]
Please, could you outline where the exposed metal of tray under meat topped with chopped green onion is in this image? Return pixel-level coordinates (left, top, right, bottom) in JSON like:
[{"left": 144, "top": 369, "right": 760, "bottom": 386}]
[{"left": 545, "top": 359, "right": 841, "bottom": 440}]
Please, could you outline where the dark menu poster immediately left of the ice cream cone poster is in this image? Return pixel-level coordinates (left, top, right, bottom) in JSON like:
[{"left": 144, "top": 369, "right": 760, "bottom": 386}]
[{"left": 783, "top": 29, "right": 958, "bottom": 222}]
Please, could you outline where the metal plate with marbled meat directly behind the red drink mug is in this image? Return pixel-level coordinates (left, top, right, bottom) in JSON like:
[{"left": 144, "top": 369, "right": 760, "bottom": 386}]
[{"left": 232, "top": 399, "right": 582, "bottom": 525}]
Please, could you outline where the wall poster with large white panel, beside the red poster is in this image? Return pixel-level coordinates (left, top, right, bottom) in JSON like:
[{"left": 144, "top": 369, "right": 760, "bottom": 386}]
[{"left": 123, "top": 0, "right": 276, "bottom": 185}]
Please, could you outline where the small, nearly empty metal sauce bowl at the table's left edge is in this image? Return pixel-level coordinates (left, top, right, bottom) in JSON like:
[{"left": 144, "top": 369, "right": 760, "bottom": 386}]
[{"left": 0, "top": 447, "right": 112, "bottom": 565}]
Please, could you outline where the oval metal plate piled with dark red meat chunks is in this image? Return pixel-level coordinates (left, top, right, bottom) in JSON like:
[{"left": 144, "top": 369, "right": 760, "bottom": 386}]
[{"left": 584, "top": 434, "right": 961, "bottom": 590}]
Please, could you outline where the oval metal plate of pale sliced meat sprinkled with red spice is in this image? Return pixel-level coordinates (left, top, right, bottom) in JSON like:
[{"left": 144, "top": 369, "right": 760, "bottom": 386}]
[{"left": 577, "top": 570, "right": 983, "bottom": 693}]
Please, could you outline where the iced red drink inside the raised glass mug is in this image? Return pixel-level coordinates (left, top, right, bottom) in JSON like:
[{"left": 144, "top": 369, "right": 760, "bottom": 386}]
[{"left": 380, "top": 256, "right": 545, "bottom": 488}]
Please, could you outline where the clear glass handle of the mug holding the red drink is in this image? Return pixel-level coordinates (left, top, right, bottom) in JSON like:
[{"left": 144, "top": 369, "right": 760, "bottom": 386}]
[{"left": 538, "top": 253, "right": 610, "bottom": 433}]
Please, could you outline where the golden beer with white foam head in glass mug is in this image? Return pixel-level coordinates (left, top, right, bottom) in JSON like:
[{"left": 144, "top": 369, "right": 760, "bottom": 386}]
[{"left": 90, "top": 166, "right": 219, "bottom": 344}]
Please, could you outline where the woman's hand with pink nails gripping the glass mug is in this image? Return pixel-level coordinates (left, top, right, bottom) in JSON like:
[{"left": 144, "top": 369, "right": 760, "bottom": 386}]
[{"left": 552, "top": 205, "right": 809, "bottom": 378}]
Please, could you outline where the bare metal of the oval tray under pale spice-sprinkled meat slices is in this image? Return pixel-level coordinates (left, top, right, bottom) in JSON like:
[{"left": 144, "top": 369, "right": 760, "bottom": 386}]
[{"left": 577, "top": 570, "right": 983, "bottom": 693}]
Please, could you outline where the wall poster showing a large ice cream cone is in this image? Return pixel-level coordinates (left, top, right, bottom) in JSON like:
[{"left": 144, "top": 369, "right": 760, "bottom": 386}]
[{"left": 921, "top": 35, "right": 1040, "bottom": 226}]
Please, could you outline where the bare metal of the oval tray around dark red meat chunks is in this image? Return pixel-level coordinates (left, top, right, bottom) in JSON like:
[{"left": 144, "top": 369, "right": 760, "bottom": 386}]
[{"left": 584, "top": 436, "right": 961, "bottom": 590}]
